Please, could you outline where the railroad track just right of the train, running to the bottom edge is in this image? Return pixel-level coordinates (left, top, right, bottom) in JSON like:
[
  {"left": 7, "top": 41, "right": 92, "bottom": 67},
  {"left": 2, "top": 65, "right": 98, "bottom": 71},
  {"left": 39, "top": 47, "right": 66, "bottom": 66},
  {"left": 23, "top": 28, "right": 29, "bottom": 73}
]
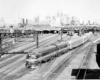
[{"left": 43, "top": 43, "right": 89, "bottom": 80}]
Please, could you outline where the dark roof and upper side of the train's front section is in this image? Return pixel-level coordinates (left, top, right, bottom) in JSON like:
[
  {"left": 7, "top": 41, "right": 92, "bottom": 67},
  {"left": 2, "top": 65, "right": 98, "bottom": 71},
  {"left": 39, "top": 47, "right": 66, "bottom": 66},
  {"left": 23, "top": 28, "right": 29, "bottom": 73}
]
[{"left": 27, "top": 42, "right": 68, "bottom": 58}]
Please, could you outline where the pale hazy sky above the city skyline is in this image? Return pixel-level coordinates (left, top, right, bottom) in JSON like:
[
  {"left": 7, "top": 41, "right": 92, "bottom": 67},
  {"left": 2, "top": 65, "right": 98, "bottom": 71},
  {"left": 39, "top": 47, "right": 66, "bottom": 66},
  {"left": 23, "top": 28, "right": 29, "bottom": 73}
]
[{"left": 0, "top": 0, "right": 100, "bottom": 23}]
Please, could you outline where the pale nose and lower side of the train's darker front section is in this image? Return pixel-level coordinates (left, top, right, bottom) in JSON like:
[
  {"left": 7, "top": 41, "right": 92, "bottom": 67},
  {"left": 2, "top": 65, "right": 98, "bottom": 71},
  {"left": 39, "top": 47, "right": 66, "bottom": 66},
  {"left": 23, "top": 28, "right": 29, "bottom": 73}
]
[{"left": 26, "top": 48, "right": 68, "bottom": 69}]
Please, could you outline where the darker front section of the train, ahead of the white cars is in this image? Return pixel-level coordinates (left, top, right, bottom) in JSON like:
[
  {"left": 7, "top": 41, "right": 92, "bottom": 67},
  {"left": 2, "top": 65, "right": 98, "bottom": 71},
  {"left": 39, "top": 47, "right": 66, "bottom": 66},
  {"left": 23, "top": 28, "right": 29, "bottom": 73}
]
[{"left": 26, "top": 42, "right": 68, "bottom": 68}]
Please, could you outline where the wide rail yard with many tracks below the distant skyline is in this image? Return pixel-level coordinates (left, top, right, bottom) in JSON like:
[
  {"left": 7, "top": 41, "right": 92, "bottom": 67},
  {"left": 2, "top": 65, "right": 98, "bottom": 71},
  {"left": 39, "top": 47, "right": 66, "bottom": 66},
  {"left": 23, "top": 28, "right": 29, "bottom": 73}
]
[{"left": 0, "top": 25, "right": 100, "bottom": 80}]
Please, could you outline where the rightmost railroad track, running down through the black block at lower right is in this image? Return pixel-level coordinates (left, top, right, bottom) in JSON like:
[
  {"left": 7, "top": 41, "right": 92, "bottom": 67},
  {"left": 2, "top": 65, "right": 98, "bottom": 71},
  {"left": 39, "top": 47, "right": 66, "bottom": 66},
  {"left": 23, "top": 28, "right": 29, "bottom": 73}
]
[{"left": 76, "top": 44, "right": 95, "bottom": 80}]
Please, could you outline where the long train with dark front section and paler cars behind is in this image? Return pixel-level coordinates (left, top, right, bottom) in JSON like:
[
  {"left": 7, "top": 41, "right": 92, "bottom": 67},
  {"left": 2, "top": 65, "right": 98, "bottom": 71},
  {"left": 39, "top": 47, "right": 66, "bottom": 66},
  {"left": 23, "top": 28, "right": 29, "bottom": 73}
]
[{"left": 25, "top": 32, "right": 93, "bottom": 69}]
